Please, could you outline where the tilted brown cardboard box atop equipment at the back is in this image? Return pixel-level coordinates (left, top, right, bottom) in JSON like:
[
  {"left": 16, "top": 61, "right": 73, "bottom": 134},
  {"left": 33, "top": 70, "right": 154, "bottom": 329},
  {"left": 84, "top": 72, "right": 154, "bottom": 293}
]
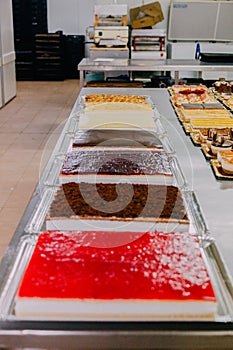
[{"left": 130, "top": 1, "right": 164, "bottom": 29}]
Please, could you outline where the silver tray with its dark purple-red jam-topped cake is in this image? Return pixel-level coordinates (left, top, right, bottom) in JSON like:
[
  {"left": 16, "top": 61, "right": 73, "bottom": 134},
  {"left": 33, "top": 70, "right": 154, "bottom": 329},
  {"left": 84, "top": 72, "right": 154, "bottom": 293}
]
[{"left": 54, "top": 147, "right": 182, "bottom": 188}]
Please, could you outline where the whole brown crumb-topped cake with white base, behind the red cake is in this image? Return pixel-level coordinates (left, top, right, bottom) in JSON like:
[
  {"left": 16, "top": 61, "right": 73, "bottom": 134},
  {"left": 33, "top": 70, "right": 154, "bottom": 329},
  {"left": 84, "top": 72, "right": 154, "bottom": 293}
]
[{"left": 46, "top": 182, "right": 190, "bottom": 232}]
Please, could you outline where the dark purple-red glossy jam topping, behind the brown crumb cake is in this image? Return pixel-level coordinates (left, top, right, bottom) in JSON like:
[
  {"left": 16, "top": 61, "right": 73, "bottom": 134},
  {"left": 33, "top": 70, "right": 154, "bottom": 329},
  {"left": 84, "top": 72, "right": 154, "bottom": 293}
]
[{"left": 61, "top": 148, "right": 172, "bottom": 176}]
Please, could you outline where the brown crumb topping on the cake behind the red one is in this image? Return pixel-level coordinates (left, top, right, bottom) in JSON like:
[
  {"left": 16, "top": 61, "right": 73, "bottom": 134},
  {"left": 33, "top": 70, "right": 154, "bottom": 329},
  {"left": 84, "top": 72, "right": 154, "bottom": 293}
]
[{"left": 47, "top": 182, "right": 189, "bottom": 223}]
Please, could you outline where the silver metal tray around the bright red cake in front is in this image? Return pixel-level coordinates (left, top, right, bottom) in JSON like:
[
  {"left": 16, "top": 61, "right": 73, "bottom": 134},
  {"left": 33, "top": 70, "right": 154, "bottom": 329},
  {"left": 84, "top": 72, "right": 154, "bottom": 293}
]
[{"left": 0, "top": 234, "right": 232, "bottom": 322}]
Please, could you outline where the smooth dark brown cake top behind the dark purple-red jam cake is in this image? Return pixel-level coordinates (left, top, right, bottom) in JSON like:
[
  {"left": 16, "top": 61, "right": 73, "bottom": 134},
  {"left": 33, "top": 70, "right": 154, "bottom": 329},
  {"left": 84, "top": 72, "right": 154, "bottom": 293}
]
[{"left": 73, "top": 129, "right": 162, "bottom": 148}]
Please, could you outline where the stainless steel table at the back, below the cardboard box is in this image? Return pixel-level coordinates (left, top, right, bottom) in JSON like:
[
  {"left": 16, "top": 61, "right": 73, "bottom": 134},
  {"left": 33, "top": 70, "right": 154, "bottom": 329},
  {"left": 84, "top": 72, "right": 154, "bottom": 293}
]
[{"left": 78, "top": 58, "right": 233, "bottom": 87}]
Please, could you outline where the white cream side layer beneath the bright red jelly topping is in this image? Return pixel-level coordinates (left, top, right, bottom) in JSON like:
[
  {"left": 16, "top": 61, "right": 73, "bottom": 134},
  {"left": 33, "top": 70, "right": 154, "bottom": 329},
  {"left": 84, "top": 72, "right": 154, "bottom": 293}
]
[{"left": 15, "top": 298, "right": 217, "bottom": 321}]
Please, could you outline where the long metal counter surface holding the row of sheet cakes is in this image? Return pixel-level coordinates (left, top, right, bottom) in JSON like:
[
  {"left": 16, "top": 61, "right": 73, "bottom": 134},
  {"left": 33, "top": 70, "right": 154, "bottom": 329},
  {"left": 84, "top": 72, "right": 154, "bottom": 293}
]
[{"left": 0, "top": 88, "right": 233, "bottom": 350}]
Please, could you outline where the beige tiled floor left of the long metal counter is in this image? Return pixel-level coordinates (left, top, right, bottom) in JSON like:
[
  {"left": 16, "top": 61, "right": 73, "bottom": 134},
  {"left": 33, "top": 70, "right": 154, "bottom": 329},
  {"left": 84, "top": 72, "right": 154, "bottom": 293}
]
[{"left": 0, "top": 80, "right": 79, "bottom": 259}]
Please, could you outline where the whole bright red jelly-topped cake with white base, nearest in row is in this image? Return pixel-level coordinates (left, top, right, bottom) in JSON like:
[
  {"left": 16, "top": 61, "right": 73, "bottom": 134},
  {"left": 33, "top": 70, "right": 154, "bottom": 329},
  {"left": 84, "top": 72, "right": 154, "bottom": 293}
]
[{"left": 15, "top": 231, "right": 217, "bottom": 321}]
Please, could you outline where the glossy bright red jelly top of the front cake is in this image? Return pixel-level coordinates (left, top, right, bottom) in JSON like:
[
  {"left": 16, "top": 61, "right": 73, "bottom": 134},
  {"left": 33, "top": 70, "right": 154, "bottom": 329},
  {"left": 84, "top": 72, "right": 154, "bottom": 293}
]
[{"left": 17, "top": 231, "right": 216, "bottom": 300}]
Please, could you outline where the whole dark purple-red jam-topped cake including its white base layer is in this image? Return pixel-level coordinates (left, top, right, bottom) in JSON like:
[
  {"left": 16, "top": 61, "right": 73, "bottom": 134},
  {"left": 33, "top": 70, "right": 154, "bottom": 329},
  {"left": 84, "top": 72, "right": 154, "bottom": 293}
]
[{"left": 59, "top": 147, "right": 173, "bottom": 184}]
